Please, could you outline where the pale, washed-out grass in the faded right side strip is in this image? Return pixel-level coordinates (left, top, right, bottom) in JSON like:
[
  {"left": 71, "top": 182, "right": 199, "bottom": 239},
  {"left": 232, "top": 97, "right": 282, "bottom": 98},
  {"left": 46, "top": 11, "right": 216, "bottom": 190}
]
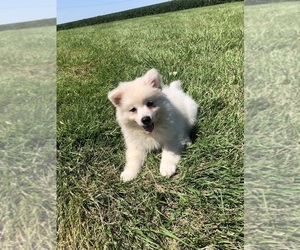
[{"left": 245, "top": 2, "right": 300, "bottom": 249}]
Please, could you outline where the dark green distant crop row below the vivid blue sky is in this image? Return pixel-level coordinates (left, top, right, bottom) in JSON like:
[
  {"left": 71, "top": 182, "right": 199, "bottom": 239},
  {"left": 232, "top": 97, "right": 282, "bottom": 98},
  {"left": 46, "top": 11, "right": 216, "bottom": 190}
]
[{"left": 57, "top": 0, "right": 243, "bottom": 30}]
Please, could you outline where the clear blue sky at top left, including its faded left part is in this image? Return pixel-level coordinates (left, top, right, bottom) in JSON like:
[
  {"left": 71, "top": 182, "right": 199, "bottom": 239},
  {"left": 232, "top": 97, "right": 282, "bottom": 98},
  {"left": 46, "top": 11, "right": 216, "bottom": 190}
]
[{"left": 0, "top": 0, "right": 168, "bottom": 24}]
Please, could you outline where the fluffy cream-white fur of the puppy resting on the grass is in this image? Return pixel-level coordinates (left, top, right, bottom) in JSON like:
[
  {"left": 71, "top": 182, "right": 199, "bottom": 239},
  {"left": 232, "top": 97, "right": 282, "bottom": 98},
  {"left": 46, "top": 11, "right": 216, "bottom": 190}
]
[{"left": 108, "top": 69, "right": 198, "bottom": 181}]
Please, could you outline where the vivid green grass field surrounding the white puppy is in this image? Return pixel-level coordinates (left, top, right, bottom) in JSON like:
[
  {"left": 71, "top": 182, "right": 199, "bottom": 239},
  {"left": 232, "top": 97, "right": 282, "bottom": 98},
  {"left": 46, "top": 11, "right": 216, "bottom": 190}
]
[{"left": 57, "top": 3, "right": 244, "bottom": 249}]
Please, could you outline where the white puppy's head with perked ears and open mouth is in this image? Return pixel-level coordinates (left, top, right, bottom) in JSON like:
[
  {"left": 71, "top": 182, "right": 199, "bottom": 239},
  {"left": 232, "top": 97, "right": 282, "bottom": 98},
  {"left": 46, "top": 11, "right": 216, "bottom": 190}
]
[{"left": 108, "top": 69, "right": 162, "bottom": 133}]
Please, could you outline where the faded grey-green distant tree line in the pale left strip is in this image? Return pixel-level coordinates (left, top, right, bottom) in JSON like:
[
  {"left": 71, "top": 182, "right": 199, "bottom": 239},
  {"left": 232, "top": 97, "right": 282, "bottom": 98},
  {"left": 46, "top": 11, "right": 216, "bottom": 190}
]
[{"left": 0, "top": 18, "right": 56, "bottom": 31}]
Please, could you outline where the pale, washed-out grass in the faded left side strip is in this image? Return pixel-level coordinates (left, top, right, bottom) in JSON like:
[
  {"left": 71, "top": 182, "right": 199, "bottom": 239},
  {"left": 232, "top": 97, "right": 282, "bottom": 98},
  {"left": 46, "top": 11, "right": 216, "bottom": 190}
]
[{"left": 0, "top": 26, "right": 56, "bottom": 249}]
